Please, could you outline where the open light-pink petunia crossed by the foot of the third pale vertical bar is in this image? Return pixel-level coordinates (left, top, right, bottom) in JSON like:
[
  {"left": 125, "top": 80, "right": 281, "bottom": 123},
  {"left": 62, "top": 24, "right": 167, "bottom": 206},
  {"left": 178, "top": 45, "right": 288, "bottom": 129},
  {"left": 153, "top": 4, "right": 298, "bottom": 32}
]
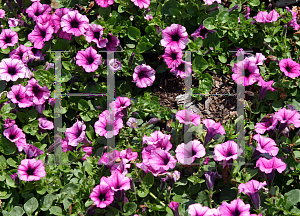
[{"left": 175, "top": 140, "right": 206, "bottom": 165}]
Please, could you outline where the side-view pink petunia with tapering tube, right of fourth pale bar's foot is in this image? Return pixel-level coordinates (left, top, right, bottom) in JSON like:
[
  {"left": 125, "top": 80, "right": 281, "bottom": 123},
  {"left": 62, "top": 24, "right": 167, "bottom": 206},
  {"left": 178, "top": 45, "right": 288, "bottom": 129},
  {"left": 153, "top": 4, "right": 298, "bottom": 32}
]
[{"left": 255, "top": 157, "right": 286, "bottom": 186}]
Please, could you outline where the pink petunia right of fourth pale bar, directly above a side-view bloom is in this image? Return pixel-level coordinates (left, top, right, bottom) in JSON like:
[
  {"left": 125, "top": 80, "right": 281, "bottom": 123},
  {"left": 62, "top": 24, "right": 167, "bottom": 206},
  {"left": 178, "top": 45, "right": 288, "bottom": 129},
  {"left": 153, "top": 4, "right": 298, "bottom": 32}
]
[{"left": 253, "top": 134, "right": 278, "bottom": 156}]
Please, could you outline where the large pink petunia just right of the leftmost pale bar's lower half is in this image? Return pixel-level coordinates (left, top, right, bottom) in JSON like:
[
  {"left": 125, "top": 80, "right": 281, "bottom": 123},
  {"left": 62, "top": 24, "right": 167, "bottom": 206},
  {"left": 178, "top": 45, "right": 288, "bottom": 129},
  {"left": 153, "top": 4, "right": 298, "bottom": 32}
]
[{"left": 65, "top": 120, "right": 86, "bottom": 147}]
